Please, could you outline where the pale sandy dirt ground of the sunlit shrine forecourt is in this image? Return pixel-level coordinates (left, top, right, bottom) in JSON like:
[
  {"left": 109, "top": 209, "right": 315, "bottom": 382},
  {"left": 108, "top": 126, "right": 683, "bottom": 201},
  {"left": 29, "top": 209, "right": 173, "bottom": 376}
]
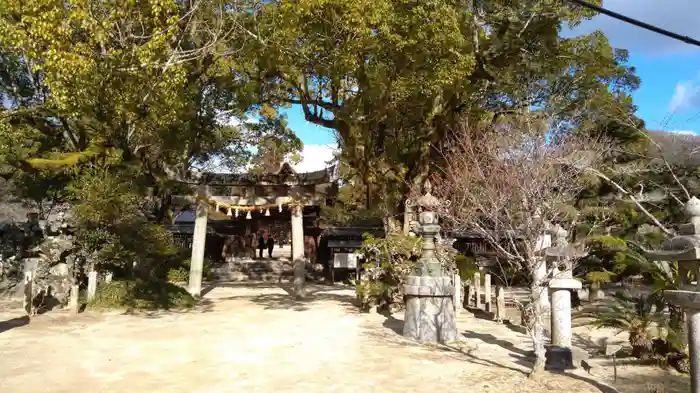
[{"left": 0, "top": 284, "right": 689, "bottom": 393}]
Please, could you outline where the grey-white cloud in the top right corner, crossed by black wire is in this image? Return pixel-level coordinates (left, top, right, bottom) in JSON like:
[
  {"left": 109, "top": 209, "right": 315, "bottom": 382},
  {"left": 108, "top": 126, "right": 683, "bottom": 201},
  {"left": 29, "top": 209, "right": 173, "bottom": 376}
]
[{"left": 574, "top": 0, "right": 700, "bottom": 55}]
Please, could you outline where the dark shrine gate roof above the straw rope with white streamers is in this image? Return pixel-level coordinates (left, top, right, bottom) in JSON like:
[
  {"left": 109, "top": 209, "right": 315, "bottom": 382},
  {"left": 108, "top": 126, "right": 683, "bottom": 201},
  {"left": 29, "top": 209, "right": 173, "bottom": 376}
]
[{"left": 200, "top": 162, "right": 337, "bottom": 186}]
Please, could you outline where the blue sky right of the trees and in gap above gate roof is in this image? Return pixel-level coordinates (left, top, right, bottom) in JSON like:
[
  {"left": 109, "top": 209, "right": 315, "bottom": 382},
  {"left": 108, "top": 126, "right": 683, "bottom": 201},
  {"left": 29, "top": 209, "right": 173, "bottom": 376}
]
[{"left": 284, "top": 0, "right": 700, "bottom": 147}]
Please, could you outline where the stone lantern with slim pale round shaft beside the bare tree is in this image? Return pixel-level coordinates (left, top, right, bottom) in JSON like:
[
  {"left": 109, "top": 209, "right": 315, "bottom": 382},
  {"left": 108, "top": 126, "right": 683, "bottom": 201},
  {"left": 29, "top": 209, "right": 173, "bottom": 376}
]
[{"left": 544, "top": 225, "right": 585, "bottom": 369}]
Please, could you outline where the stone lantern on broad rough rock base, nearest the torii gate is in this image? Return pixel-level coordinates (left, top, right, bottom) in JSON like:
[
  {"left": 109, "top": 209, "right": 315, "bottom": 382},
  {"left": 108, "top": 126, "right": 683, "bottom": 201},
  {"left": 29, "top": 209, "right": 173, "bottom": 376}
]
[{"left": 403, "top": 181, "right": 457, "bottom": 343}]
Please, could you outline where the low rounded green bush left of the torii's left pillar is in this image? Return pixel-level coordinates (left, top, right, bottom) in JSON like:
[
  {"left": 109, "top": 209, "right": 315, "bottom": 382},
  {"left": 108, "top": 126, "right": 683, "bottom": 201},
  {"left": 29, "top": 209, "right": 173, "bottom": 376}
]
[{"left": 88, "top": 279, "right": 196, "bottom": 310}]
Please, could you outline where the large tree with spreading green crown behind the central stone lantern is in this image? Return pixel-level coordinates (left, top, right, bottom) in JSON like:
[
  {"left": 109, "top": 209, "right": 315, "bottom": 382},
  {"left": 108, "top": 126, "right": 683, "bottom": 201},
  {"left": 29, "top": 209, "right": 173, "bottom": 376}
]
[{"left": 241, "top": 0, "right": 639, "bottom": 230}]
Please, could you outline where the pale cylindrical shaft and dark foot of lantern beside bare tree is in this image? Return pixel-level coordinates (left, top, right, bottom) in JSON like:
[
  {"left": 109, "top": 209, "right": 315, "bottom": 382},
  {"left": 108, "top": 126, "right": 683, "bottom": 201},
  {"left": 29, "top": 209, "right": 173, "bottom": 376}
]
[{"left": 547, "top": 278, "right": 581, "bottom": 369}]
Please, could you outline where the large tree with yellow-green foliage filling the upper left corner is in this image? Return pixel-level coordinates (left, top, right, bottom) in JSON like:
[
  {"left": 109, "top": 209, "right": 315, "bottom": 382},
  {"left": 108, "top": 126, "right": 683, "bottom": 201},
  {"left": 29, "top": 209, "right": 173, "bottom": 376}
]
[{"left": 0, "top": 0, "right": 290, "bottom": 220}]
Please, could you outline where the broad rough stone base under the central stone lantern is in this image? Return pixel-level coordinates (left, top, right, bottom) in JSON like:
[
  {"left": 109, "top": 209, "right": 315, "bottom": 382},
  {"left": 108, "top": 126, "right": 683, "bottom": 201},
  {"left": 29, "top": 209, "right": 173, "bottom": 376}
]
[{"left": 403, "top": 276, "right": 457, "bottom": 343}]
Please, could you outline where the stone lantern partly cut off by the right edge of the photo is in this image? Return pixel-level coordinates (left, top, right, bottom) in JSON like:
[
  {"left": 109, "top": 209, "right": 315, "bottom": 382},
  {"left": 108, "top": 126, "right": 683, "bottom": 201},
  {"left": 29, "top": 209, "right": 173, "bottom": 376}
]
[{"left": 645, "top": 197, "right": 700, "bottom": 393}]
